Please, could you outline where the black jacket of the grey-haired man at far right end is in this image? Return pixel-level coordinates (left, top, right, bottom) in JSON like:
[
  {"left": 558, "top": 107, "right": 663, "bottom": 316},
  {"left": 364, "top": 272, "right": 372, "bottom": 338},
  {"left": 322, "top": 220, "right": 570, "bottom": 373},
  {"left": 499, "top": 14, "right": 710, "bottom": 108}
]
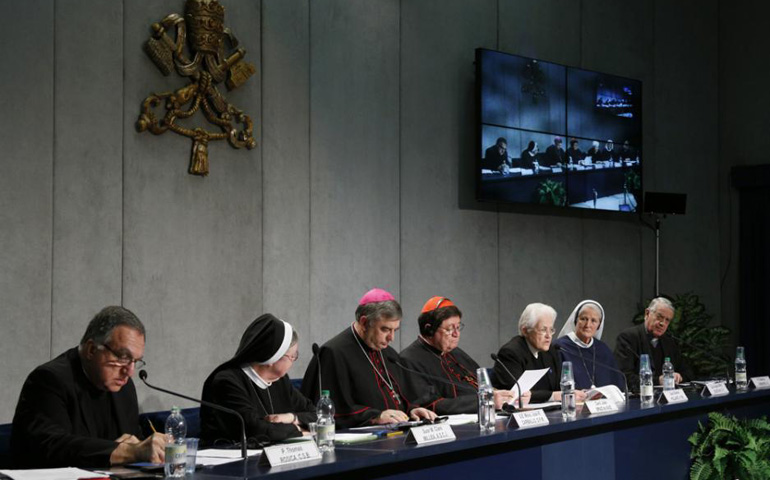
[{"left": 615, "top": 324, "right": 693, "bottom": 392}]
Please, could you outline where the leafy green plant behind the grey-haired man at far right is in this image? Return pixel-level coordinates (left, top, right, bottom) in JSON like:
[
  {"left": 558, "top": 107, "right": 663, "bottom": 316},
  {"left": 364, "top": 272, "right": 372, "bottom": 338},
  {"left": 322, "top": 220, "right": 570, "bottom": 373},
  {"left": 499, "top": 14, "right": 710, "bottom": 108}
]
[{"left": 633, "top": 292, "right": 732, "bottom": 378}]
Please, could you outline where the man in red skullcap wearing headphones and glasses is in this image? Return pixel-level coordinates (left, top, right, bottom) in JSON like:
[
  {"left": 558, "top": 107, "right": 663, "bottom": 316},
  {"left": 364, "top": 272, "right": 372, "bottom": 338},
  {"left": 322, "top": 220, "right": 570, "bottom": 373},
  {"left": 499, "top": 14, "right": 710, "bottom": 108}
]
[{"left": 401, "top": 297, "right": 513, "bottom": 415}]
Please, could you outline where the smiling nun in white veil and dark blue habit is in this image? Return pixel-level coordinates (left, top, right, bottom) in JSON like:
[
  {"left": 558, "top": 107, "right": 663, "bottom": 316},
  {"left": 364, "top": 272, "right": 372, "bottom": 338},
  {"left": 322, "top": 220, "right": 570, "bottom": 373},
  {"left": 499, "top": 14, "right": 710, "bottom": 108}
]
[{"left": 554, "top": 300, "right": 625, "bottom": 390}]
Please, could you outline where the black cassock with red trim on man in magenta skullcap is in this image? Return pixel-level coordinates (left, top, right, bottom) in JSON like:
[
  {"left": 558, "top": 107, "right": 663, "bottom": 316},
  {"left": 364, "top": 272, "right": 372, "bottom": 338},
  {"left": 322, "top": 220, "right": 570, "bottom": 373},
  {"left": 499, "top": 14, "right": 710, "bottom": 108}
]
[{"left": 302, "top": 327, "right": 429, "bottom": 428}]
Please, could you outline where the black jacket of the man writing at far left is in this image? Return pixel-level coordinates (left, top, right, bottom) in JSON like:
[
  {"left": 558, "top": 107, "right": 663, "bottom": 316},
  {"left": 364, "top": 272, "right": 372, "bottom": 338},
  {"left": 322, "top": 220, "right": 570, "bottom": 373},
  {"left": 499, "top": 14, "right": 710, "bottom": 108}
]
[{"left": 11, "top": 347, "right": 141, "bottom": 468}]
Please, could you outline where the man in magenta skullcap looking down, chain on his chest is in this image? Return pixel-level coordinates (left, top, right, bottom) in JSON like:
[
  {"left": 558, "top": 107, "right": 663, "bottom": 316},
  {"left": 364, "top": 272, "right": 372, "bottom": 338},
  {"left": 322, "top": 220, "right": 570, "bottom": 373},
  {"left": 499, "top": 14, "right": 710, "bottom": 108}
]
[{"left": 302, "top": 288, "right": 436, "bottom": 428}]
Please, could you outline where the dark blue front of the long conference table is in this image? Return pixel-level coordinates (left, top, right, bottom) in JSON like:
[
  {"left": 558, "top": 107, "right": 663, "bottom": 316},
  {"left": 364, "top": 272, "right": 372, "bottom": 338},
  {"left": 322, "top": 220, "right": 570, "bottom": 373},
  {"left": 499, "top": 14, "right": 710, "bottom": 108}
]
[{"left": 188, "top": 390, "right": 770, "bottom": 480}]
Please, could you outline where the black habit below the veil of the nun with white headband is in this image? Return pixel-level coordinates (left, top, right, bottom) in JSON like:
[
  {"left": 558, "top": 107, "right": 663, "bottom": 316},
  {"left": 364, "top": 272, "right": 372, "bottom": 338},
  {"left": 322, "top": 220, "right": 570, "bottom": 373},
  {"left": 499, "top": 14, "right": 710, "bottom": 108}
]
[{"left": 200, "top": 366, "right": 316, "bottom": 445}]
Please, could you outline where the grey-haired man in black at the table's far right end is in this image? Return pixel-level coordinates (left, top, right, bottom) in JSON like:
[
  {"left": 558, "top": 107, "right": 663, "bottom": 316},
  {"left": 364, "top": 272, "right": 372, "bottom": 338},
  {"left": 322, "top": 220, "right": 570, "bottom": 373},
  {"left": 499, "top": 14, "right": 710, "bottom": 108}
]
[{"left": 615, "top": 297, "right": 693, "bottom": 392}]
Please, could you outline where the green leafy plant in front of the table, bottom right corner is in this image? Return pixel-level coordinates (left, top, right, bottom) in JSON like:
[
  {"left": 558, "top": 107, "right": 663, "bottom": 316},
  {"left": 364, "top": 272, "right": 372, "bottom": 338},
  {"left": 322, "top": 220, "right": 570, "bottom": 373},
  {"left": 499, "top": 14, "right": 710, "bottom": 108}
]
[{"left": 687, "top": 412, "right": 770, "bottom": 480}]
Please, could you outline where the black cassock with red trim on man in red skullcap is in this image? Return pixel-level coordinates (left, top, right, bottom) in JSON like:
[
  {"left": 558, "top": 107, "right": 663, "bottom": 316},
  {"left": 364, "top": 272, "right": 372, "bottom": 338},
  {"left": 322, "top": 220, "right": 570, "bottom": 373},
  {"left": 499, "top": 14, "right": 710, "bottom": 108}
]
[{"left": 400, "top": 338, "right": 479, "bottom": 415}]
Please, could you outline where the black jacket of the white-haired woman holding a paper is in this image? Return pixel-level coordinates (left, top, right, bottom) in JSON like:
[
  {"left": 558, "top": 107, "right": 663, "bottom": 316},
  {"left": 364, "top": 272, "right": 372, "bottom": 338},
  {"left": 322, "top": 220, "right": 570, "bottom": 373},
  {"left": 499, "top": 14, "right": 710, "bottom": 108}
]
[{"left": 494, "top": 335, "right": 561, "bottom": 403}]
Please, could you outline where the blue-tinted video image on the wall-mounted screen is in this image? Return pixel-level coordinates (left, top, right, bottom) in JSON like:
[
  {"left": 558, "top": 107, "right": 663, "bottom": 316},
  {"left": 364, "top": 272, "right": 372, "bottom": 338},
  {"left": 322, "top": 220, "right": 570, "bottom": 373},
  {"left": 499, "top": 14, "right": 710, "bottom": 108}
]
[{"left": 476, "top": 49, "right": 642, "bottom": 212}]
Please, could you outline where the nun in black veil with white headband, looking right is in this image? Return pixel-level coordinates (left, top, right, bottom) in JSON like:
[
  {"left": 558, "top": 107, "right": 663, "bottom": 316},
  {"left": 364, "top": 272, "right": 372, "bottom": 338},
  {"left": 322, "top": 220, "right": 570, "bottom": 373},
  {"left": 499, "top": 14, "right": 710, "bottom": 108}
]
[{"left": 200, "top": 313, "right": 316, "bottom": 446}]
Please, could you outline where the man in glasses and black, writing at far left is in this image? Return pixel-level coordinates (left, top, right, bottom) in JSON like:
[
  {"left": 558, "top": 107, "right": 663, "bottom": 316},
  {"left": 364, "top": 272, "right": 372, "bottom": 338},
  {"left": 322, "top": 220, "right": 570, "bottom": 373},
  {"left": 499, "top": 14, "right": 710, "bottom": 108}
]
[{"left": 11, "top": 307, "right": 166, "bottom": 468}]
